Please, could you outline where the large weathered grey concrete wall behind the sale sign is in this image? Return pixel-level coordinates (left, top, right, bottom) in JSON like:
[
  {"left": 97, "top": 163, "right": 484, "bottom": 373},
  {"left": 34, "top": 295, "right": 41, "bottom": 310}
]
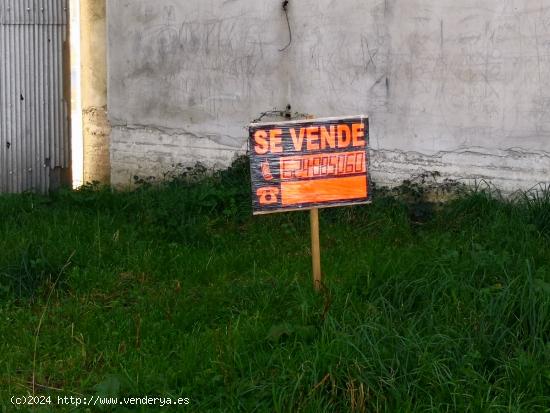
[{"left": 108, "top": 0, "right": 550, "bottom": 190}]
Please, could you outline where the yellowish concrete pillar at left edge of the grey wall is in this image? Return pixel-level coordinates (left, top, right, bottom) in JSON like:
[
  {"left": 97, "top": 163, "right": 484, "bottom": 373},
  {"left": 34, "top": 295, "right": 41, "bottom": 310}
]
[{"left": 80, "top": 0, "right": 111, "bottom": 184}]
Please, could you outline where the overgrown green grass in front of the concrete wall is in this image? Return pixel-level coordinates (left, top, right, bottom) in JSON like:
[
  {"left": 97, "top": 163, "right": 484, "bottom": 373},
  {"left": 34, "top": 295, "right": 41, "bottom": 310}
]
[{"left": 0, "top": 159, "right": 550, "bottom": 412}]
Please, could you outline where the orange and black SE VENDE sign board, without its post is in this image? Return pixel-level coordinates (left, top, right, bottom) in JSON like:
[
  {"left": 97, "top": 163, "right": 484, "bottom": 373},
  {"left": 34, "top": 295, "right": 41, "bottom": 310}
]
[{"left": 249, "top": 116, "right": 370, "bottom": 214}]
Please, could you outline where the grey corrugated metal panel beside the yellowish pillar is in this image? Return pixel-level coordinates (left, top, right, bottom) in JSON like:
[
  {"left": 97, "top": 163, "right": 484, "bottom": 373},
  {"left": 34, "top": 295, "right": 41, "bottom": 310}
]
[{"left": 0, "top": 0, "right": 70, "bottom": 192}]
